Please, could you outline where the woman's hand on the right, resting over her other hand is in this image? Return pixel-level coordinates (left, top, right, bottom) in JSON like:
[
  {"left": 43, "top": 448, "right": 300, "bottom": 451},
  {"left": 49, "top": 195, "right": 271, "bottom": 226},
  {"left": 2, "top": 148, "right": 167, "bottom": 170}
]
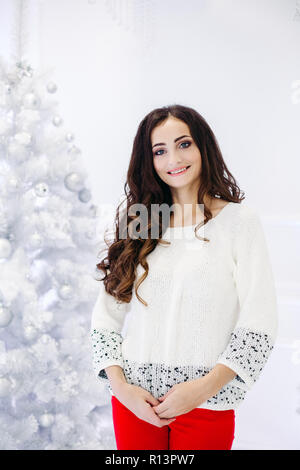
[{"left": 152, "top": 377, "right": 212, "bottom": 419}]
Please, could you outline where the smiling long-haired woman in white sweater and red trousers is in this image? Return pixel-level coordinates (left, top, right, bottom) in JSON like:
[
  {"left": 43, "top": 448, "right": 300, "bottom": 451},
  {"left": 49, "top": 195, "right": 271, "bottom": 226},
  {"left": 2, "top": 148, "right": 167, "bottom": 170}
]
[{"left": 91, "top": 105, "right": 278, "bottom": 450}]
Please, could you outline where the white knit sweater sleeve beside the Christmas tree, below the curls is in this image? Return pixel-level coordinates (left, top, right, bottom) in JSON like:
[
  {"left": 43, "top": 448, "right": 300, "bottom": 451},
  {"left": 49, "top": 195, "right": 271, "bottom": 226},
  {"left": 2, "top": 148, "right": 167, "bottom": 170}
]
[{"left": 90, "top": 281, "right": 130, "bottom": 386}]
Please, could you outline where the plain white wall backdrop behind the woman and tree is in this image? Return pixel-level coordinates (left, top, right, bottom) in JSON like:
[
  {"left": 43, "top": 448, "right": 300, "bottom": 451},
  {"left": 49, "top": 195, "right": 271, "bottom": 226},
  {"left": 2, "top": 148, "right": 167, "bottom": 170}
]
[{"left": 0, "top": 0, "right": 300, "bottom": 449}]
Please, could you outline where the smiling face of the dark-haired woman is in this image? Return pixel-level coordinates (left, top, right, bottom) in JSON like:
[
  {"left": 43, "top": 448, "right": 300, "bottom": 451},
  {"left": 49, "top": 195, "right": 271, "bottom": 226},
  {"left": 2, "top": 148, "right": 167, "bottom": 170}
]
[{"left": 151, "top": 117, "right": 201, "bottom": 188}]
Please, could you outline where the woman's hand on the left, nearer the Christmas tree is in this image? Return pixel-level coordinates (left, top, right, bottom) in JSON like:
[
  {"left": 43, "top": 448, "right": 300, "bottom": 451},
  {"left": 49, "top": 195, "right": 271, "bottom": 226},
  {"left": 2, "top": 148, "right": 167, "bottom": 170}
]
[{"left": 113, "top": 382, "right": 174, "bottom": 428}]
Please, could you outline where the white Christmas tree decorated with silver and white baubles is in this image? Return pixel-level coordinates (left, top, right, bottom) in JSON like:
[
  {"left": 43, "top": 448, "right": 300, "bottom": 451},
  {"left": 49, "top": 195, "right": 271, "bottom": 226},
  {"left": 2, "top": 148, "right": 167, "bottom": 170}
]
[{"left": 0, "top": 59, "right": 115, "bottom": 450}]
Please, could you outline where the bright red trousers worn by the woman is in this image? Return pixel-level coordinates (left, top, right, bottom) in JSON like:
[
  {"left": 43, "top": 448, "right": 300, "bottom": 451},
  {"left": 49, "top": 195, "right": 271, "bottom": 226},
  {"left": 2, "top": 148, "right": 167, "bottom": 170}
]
[{"left": 111, "top": 395, "right": 235, "bottom": 450}]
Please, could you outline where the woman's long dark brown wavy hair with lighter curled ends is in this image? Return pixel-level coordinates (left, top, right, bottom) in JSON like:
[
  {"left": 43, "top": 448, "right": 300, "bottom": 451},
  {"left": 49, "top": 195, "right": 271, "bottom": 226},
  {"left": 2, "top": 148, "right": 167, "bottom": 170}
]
[{"left": 96, "top": 104, "right": 245, "bottom": 306}]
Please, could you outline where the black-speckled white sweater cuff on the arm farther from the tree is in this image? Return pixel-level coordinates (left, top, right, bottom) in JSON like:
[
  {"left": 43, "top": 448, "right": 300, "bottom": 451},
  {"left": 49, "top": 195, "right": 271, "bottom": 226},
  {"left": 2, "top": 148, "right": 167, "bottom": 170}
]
[{"left": 217, "top": 327, "right": 273, "bottom": 391}]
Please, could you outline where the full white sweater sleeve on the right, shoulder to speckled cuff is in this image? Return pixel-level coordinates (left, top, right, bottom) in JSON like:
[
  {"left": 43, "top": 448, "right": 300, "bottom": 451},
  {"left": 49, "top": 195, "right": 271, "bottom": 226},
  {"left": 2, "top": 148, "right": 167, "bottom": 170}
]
[{"left": 217, "top": 206, "right": 278, "bottom": 391}]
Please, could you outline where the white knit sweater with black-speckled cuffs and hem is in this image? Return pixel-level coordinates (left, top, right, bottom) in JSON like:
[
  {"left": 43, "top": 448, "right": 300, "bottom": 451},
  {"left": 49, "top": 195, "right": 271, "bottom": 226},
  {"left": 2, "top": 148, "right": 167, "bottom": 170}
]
[{"left": 91, "top": 202, "right": 278, "bottom": 410}]
